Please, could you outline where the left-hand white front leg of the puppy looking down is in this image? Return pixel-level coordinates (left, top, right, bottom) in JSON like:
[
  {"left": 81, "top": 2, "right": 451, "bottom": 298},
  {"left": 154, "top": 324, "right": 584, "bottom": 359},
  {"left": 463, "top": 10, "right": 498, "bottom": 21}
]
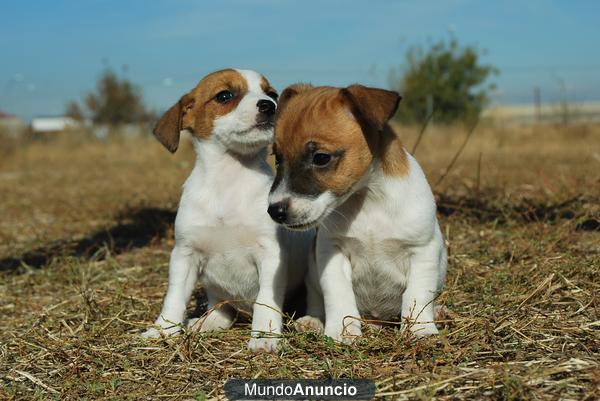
[{"left": 317, "top": 233, "right": 361, "bottom": 344}]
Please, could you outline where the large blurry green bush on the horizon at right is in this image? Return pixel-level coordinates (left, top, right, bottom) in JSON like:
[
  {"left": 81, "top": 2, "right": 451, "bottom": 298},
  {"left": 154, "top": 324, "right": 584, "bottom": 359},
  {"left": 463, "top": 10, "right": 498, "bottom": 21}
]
[{"left": 391, "top": 37, "right": 498, "bottom": 123}]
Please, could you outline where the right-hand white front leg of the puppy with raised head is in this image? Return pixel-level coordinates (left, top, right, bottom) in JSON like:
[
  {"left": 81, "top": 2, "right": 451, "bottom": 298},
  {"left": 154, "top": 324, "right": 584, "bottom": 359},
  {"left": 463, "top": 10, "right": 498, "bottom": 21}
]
[{"left": 248, "top": 242, "right": 287, "bottom": 352}]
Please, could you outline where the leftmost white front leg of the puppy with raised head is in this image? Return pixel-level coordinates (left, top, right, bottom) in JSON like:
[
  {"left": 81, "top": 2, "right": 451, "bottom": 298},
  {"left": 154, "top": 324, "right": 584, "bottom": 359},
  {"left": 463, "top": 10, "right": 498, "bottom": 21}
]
[{"left": 142, "top": 245, "right": 200, "bottom": 338}]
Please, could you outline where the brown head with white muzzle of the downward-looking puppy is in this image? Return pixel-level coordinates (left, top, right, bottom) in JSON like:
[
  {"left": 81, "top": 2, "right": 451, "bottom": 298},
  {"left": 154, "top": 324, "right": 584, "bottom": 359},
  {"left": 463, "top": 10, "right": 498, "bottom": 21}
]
[{"left": 268, "top": 84, "right": 400, "bottom": 230}]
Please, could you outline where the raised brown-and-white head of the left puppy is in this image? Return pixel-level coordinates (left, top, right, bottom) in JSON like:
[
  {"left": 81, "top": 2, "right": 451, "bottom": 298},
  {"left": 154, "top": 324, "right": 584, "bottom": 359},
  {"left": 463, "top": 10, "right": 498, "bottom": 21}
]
[{"left": 153, "top": 69, "right": 277, "bottom": 154}]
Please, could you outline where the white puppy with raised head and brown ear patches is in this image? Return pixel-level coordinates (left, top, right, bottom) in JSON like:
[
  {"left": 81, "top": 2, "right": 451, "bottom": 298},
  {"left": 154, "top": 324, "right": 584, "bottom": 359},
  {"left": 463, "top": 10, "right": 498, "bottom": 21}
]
[{"left": 142, "top": 69, "right": 311, "bottom": 351}]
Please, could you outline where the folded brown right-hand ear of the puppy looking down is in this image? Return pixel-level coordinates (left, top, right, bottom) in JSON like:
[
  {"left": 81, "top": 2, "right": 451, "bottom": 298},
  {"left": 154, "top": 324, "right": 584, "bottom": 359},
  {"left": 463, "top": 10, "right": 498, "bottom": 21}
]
[{"left": 341, "top": 85, "right": 402, "bottom": 131}]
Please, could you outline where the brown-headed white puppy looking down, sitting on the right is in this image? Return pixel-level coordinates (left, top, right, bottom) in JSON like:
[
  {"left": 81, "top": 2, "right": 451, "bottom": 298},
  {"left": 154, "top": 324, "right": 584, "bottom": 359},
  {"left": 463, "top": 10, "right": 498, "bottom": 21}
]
[{"left": 268, "top": 84, "right": 447, "bottom": 342}]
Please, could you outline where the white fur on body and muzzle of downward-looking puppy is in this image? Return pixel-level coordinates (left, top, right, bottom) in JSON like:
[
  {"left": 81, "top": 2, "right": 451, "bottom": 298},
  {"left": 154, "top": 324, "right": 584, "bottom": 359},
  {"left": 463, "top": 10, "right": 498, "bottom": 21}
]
[{"left": 269, "top": 153, "right": 447, "bottom": 342}]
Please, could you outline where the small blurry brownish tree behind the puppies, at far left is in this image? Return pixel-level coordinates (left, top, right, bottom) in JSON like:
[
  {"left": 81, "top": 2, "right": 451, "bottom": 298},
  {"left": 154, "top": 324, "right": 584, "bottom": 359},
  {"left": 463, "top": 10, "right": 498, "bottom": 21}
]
[{"left": 66, "top": 70, "right": 151, "bottom": 126}]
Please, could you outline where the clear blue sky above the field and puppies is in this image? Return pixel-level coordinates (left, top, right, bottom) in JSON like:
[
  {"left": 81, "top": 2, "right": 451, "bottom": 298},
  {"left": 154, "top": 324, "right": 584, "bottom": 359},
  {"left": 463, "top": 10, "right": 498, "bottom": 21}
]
[{"left": 0, "top": 0, "right": 600, "bottom": 119}]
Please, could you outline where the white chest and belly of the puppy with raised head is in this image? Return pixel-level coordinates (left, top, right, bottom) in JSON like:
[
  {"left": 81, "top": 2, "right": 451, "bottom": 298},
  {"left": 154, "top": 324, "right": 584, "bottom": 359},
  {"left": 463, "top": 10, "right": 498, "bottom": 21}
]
[{"left": 175, "top": 159, "right": 276, "bottom": 307}]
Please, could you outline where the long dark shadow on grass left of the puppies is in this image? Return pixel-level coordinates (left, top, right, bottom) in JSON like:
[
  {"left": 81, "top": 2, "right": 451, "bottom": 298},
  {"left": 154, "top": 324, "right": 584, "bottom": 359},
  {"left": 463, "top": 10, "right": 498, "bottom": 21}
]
[{"left": 0, "top": 208, "right": 175, "bottom": 272}]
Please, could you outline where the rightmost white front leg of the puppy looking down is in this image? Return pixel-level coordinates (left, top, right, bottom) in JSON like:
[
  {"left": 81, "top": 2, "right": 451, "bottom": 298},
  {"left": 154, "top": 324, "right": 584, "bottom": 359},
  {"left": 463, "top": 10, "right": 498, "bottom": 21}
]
[{"left": 402, "top": 240, "right": 441, "bottom": 336}]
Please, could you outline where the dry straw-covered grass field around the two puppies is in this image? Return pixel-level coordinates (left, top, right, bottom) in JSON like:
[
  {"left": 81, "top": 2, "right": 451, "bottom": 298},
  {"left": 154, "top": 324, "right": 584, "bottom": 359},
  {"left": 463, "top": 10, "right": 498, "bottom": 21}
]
[{"left": 0, "top": 125, "right": 600, "bottom": 400}]
